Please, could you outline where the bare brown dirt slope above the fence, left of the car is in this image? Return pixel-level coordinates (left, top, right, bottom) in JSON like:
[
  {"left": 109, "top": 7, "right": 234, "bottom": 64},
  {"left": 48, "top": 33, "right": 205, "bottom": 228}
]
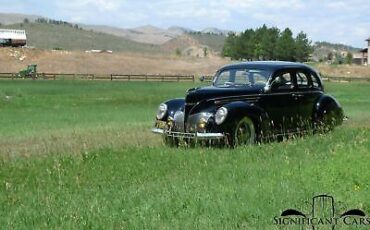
[{"left": 0, "top": 48, "right": 230, "bottom": 75}]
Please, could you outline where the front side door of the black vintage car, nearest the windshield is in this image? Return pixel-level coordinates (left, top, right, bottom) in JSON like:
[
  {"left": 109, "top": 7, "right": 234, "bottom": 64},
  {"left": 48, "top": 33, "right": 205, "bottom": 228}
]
[{"left": 263, "top": 69, "right": 299, "bottom": 134}]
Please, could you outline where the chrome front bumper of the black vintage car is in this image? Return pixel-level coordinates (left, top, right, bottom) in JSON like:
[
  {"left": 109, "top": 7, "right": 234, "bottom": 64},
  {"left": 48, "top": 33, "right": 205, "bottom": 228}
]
[{"left": 152, "top": 128, "right": 225, "bottom": 140}]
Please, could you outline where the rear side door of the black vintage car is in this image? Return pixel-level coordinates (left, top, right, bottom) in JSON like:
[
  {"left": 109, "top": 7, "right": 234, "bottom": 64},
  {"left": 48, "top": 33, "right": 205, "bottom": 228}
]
[{"left": 295, "top": 69, "right": 322, "bottom": 129}]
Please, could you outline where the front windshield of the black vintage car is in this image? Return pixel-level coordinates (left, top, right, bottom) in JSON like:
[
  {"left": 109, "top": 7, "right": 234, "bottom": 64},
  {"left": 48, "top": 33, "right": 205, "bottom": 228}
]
[{"left": 213, "top": 69, "right": 271, "bottom": 87}]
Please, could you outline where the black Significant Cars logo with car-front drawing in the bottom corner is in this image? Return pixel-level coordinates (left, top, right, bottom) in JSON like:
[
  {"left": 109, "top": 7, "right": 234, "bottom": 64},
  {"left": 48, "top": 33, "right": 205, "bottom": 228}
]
[{"left": 273, "top": 195, "right": 370, "bottom": 229}]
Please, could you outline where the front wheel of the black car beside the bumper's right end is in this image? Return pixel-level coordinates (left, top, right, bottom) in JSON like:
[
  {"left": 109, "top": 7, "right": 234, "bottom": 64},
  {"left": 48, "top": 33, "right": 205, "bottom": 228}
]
[{"left": 229, "top": 117, "right": 256, "bottom": 147}]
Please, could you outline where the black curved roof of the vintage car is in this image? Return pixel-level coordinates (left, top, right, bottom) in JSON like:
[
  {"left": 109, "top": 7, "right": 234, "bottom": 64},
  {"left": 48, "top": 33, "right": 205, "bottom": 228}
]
[{"left": 220, "top": 61, "right": 316, "bottom": 72}]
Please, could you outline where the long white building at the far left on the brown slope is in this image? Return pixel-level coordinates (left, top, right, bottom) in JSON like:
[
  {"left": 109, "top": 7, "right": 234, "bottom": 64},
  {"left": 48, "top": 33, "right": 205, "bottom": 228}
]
[{"left": 0, "top": 29, "right": 27, "bottom": 46}]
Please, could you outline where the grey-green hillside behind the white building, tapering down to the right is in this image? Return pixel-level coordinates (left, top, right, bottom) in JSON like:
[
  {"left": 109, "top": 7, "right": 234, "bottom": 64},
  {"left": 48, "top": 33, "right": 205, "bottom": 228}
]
[{"left": 2, "top": 23, "right": 161, "bottom": 53}]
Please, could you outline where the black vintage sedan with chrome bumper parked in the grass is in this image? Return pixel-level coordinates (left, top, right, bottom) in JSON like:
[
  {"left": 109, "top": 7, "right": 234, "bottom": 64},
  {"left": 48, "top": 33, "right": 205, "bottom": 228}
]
[{"left": 152, "top": 61, "right": 343, "bottom": 146}]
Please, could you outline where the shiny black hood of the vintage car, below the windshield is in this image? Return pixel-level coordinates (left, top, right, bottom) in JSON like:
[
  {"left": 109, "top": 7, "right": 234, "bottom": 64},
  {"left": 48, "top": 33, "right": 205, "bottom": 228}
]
[{"left": 185, "top": 86, "right": 263, "bottom": 104}]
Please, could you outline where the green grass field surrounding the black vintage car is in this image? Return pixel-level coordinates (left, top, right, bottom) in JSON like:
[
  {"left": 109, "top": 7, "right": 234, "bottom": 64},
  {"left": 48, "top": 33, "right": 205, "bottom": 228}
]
[{"left": 0, "top": 80, "right": 370, "bottom": 229}]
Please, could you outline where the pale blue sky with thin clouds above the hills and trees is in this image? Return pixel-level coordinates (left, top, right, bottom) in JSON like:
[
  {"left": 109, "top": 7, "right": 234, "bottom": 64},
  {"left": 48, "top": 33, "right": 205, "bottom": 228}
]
[{"left": 0, "top": 0, "right": 370, "bottom": 47}]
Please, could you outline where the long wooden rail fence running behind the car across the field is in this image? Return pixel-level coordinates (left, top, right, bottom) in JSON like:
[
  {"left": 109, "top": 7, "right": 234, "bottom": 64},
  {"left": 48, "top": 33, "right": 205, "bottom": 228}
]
[{"left": 0, "top": 73, "right": 370, "bottom": 82}]
